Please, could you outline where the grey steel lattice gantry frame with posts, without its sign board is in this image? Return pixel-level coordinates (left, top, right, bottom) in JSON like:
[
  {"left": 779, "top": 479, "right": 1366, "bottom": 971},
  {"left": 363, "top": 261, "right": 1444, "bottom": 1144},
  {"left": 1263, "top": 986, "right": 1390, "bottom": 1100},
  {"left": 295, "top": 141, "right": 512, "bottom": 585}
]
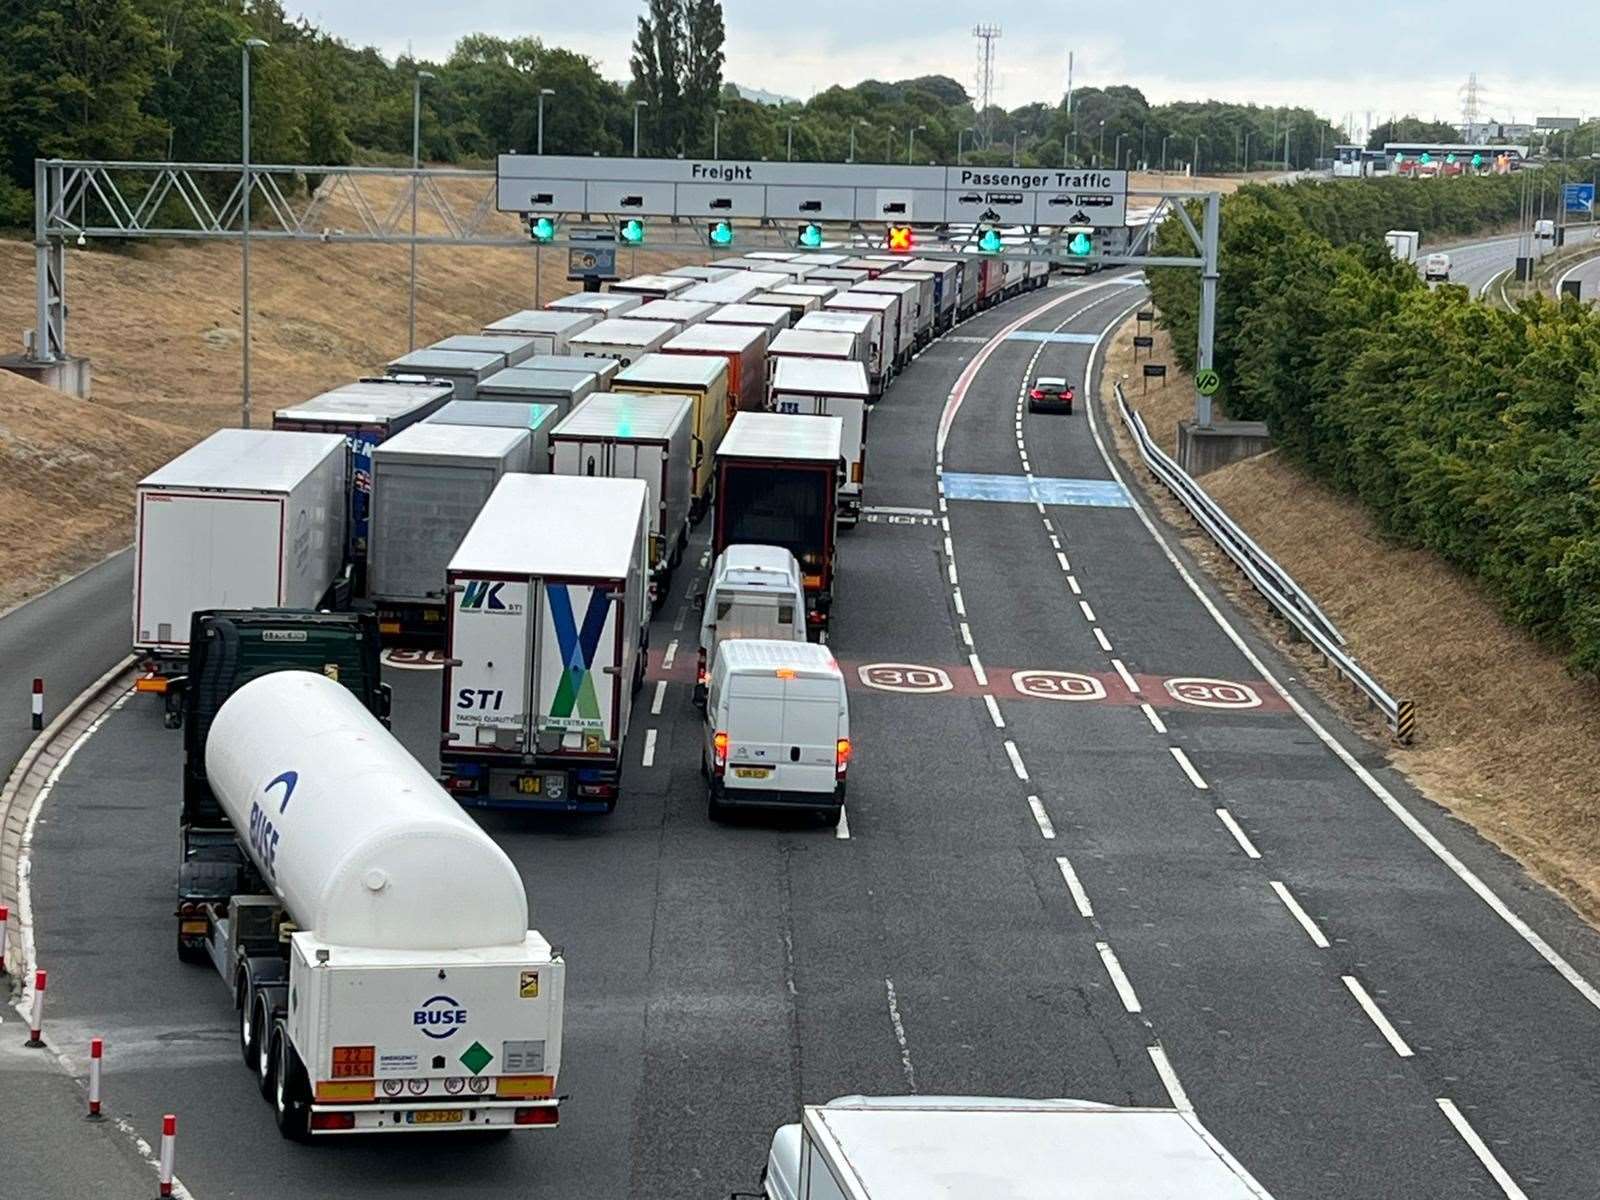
[{"left": 32, "top": 158, "right": 1219, "bottom": 424}]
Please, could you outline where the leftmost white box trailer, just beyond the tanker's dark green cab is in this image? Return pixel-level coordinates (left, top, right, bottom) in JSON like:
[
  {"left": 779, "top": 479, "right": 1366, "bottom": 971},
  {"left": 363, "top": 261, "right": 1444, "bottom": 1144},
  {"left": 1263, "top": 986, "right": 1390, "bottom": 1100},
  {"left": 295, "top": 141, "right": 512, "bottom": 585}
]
[{"left": 133, "top": 429, "right": 349, "bottom": 677}]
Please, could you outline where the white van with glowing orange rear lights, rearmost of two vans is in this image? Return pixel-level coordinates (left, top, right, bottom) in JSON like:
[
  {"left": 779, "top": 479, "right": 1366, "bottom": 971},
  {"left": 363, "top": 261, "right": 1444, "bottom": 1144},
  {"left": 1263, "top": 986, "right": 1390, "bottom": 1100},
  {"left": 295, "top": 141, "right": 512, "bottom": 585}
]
[{"left": 701, "top": 638, "right": 851, "bottom": 826}]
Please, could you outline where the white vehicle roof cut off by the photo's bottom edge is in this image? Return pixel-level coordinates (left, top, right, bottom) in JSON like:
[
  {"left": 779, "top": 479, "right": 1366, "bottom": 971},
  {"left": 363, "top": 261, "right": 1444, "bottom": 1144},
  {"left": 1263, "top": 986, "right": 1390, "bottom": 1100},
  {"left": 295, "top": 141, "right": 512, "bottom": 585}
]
[{"left": 760, "top": 1096, "right": 1272, "bottom": 1200}]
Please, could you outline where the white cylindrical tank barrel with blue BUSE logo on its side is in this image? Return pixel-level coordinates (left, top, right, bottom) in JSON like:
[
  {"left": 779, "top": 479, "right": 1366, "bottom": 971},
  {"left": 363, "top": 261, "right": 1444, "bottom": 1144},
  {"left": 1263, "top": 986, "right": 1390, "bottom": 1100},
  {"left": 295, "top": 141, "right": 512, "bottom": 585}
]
[{"left": 205, "top": 670, "right": 528, "bottom": 950}]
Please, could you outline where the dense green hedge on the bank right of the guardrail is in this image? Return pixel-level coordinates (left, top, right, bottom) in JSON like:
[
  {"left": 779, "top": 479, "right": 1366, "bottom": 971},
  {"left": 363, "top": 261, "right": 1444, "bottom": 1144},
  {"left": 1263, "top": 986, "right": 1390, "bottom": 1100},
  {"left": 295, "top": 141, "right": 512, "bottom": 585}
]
[{"left": 1149, "top": 168, "right": 1600, "bottom": 674}]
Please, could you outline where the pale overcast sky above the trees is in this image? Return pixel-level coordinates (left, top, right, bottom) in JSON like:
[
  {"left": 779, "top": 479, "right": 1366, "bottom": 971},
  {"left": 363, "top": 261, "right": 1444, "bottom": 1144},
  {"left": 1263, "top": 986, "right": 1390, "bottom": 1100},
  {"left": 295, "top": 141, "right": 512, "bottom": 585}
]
[{"left": 305, "top": 0, "right": 1600, "bottom": 136}]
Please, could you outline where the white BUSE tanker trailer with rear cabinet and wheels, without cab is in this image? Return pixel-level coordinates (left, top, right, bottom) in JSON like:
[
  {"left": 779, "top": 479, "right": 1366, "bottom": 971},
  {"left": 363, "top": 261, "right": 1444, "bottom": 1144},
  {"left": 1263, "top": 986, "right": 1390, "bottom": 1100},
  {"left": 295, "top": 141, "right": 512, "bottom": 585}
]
[{"left": 205, "top": 670, "right": 566, "bottom": 1141}]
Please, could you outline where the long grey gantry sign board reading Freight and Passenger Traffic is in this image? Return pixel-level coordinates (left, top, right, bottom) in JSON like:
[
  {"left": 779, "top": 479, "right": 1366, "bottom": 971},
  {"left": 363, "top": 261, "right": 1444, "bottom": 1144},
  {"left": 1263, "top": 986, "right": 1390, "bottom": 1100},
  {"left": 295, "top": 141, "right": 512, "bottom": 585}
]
[{"left": 498, "top": 154, "right": 1128, "bottom": 229}]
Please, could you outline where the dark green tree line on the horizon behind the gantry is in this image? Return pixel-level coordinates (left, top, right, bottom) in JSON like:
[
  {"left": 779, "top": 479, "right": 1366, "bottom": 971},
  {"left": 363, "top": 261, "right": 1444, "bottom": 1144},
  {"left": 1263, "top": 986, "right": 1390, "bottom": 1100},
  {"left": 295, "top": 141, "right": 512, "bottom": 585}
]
[{"left": 0, "top": 0, "right": 1339, "bottom": 226}]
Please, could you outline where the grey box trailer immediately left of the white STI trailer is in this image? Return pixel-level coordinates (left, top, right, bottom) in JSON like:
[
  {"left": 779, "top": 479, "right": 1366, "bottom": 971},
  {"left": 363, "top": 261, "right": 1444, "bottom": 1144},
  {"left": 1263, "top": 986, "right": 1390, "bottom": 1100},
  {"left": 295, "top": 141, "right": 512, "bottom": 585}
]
[{"left": 366, "top": 422, "right": 530, "bottom": 640}]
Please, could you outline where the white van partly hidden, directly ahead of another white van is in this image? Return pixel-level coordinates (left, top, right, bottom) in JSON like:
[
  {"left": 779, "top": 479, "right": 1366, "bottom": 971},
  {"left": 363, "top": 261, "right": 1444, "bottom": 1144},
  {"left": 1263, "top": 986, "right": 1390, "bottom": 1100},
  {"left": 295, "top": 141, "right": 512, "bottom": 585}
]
[{"left": 694, "top": 544, "right": 806, "bottom": 704}]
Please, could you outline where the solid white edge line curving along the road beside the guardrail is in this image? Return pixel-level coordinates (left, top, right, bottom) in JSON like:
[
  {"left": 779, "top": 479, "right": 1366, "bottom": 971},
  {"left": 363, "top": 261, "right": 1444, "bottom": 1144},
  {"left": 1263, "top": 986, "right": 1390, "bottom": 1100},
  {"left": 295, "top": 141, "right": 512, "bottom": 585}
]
[{"left": 1083, "top": 305, "right": 1600, "bottom": 1008}]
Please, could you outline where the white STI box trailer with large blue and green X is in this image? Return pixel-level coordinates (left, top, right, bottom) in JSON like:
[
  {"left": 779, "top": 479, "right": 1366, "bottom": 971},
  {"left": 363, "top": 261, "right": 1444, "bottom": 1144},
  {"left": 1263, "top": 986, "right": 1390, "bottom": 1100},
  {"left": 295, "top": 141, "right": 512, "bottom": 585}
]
[{"left": 438, "top": 475, "right": 650, "bottom": 813}]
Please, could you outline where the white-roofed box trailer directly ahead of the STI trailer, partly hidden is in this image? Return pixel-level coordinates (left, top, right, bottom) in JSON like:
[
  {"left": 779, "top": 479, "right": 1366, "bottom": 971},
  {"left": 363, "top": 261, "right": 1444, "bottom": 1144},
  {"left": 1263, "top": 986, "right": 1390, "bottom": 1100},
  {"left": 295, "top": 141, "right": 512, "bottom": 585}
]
[{"left": 550, "top": 392, "right": 694, "bottom": 605}]
